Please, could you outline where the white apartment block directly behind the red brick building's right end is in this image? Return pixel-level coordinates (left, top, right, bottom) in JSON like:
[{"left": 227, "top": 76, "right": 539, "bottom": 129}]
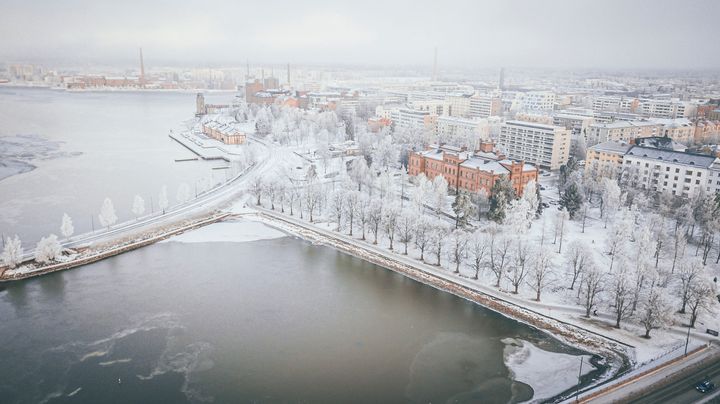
[{"left": 498, "top": 121, "right": 570, "bottom": 170}]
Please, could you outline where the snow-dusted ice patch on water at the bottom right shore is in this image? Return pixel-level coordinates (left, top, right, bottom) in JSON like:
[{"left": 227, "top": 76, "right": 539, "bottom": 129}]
[{"left": 502, "top": 338, "right": 595, "bottom": 402}]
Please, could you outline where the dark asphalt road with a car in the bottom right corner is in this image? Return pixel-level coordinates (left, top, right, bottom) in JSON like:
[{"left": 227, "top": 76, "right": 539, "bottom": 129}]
[{"left": 630, "top": 355, "right": 720, "bottom": 404}]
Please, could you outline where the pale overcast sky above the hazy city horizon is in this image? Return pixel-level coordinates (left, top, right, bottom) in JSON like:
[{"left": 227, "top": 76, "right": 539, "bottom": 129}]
[{"left": 0, "top": 0, "right": 720, "bottom": 68}]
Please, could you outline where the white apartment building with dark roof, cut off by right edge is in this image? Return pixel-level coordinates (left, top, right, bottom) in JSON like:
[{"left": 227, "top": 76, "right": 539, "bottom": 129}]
[{"left": 622, "top": 146, "right": 720, "bottom": 197}]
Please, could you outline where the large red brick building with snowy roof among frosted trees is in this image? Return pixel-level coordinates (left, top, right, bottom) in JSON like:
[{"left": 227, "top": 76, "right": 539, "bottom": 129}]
[{"left": 408, "top": 143, "right": 538, "bottom": 195}]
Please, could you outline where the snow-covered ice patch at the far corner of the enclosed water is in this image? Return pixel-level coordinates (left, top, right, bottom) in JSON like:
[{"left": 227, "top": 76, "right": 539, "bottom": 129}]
[{"left": 162, "top": 220, "right": 286, "bottom": 243}]
